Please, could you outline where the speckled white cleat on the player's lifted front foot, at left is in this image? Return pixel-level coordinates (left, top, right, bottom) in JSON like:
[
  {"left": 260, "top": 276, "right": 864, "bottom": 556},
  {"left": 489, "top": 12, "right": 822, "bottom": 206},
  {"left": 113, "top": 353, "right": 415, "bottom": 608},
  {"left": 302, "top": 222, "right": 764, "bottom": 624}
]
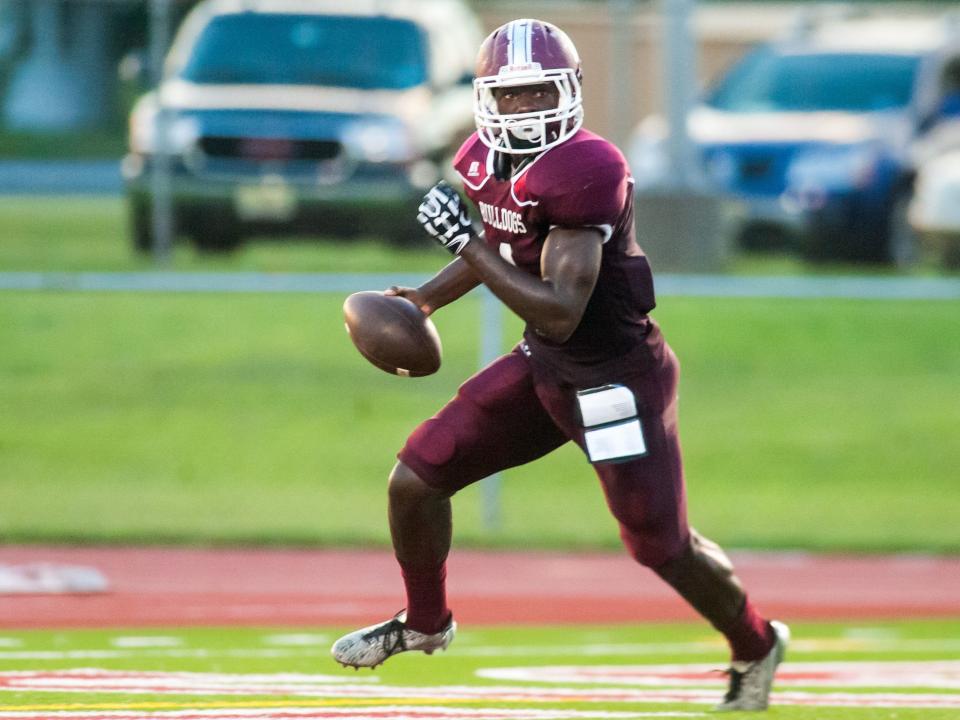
[{"left": 330, "top": 610, "right": 457, "bottom": 669}]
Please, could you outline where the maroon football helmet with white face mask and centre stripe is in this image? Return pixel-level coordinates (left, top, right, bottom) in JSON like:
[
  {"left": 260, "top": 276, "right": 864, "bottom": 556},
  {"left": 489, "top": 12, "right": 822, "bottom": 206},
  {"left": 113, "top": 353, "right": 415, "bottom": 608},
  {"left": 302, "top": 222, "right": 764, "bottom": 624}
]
[{"left": 473, "top": 19, "right": 583, "bottom": 155}]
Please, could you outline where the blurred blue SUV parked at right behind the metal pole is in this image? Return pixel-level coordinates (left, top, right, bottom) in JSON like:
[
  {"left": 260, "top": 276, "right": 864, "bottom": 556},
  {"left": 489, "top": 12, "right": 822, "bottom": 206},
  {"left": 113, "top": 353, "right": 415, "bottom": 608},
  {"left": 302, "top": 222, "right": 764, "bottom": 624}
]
[{"left": 631, "top": 16, "right": 960, "bottom": 264}]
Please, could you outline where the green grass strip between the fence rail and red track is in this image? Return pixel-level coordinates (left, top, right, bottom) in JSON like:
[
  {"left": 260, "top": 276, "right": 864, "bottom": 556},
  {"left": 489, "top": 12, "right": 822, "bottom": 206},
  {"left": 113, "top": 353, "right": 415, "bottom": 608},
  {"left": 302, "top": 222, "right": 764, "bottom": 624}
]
[{"left": 0, "top": 292, "right": 960, "bottom": 551}]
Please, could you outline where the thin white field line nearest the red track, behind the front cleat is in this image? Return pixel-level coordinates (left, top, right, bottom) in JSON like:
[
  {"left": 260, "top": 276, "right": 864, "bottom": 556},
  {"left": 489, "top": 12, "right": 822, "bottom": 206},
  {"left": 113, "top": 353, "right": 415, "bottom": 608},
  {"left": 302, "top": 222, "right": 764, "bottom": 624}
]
[{"left": 0, "top": 637, "right": 960, "bottom": 661}]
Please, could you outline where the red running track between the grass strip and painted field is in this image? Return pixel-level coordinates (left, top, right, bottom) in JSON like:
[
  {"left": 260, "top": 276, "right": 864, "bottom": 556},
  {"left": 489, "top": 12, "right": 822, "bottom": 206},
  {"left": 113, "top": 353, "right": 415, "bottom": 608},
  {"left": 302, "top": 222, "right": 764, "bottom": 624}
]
[{"left": 0, "top": 546, "right": 960, "bottom": 628}]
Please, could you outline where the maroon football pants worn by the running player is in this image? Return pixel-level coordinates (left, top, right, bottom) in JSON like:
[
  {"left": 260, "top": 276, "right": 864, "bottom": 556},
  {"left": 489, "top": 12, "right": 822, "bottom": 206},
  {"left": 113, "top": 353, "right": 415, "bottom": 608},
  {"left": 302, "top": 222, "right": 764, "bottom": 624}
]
[{"left": 398, "top": 329, "right": 689, "bottom": 567}]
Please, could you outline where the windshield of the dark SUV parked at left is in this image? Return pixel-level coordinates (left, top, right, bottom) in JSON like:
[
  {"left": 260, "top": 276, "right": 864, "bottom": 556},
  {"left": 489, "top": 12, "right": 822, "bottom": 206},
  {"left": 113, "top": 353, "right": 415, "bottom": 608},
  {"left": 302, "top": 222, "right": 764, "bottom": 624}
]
[{"left": 179, "top": 13, "right": 426, "bottom": 90}]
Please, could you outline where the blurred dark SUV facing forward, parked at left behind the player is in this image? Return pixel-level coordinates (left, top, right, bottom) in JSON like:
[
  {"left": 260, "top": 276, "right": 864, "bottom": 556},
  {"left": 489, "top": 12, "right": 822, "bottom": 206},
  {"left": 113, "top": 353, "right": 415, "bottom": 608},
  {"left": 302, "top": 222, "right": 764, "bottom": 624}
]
[{"left": 123, "top": 0, "right": 481, "bottom": 251}]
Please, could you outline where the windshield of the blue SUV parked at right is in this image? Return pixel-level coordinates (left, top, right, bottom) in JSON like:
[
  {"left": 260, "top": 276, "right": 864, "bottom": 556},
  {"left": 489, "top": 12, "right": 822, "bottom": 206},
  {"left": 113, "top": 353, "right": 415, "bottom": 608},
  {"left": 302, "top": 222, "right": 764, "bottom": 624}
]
[{"left": 707, "top": 48, "right": 920, "bottom": 112}]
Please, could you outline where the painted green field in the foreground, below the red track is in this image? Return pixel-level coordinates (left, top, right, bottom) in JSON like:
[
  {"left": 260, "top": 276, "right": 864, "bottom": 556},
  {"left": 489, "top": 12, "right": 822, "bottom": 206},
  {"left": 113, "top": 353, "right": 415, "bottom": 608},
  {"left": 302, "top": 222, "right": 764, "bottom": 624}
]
[{"left": 0, "top": 621, "right": 960, "bottom": 720}]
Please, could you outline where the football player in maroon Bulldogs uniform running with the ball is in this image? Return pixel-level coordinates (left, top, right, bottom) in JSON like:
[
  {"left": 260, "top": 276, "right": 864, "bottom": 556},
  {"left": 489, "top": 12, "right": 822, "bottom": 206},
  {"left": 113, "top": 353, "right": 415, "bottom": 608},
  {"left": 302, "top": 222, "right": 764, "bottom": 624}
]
[{"left": 332, "top": 20, "right": 789, "bottom": 710}]
